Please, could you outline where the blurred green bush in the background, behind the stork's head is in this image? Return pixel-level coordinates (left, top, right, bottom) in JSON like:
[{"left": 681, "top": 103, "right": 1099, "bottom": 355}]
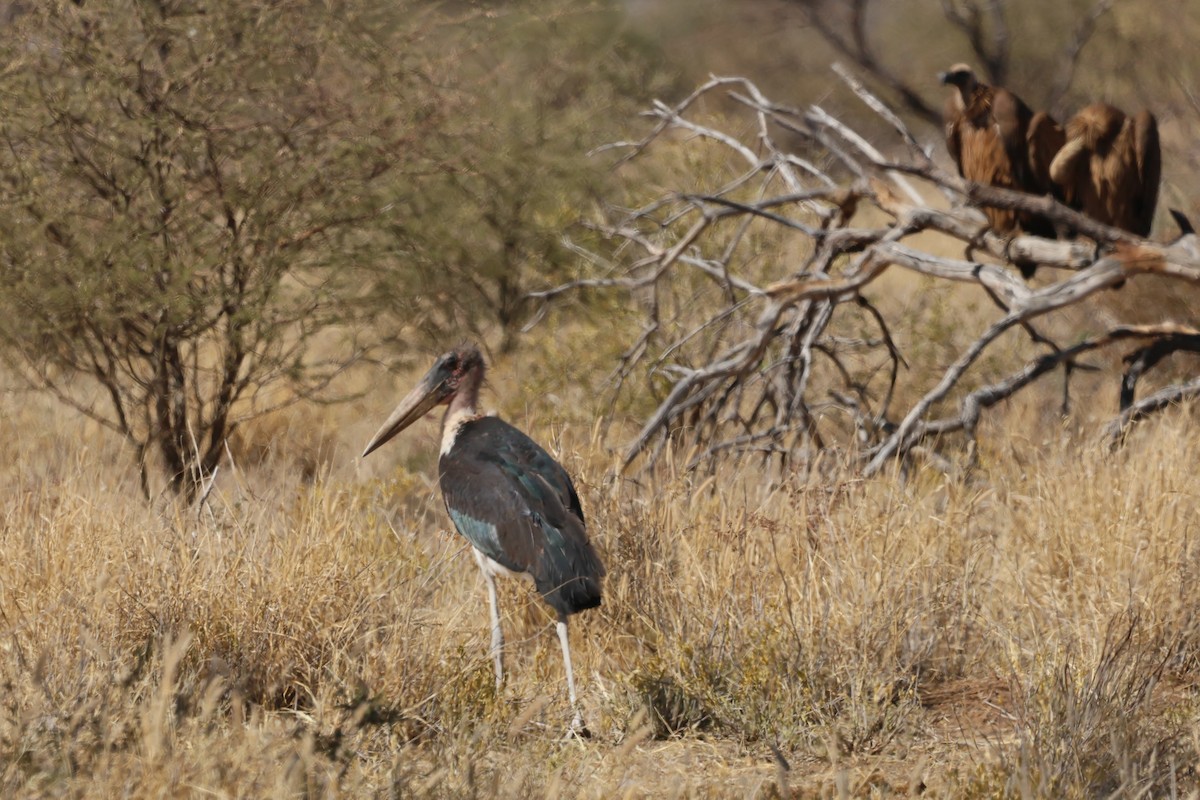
[{"left": 385, "top": 0, "right": 665, "bottom": 349}]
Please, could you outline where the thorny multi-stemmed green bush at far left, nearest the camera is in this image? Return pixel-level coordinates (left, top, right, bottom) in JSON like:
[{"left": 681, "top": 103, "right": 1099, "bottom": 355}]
[{"left": 0, "top": 0, "right": 407, "bottom": 494}]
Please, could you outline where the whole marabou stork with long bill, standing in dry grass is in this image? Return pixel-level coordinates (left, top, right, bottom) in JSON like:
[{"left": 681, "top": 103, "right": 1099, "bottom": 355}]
[{"left": 362, "top": 345, "right": 605, "bottom": 732}]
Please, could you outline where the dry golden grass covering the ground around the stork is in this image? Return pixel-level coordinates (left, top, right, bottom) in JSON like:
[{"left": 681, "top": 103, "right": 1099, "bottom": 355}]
[{"left": 0, "top": 303, "right": 1200, "bottom": 798}]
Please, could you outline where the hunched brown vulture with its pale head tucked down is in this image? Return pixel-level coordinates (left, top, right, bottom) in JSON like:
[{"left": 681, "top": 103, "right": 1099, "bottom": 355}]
[{"left": 1050, "top": 103, "right": 1162, "bottom": 236}]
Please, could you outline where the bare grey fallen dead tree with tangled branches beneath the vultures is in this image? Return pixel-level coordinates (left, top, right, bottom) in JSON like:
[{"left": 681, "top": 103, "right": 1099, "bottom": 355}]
[{"left": 539, "top": 67, "right": 1200, "bottom": 475}]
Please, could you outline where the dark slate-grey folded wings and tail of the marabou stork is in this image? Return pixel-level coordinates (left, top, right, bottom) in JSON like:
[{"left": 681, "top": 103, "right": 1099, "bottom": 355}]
[{"left": 439, "top": 417, "right": 605, "bottom": 614}]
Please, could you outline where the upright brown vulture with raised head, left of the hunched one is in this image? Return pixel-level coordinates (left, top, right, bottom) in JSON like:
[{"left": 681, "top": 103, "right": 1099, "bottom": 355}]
[{"left": 938, "top": 64, "right": 1064, "bottom": 277}]
